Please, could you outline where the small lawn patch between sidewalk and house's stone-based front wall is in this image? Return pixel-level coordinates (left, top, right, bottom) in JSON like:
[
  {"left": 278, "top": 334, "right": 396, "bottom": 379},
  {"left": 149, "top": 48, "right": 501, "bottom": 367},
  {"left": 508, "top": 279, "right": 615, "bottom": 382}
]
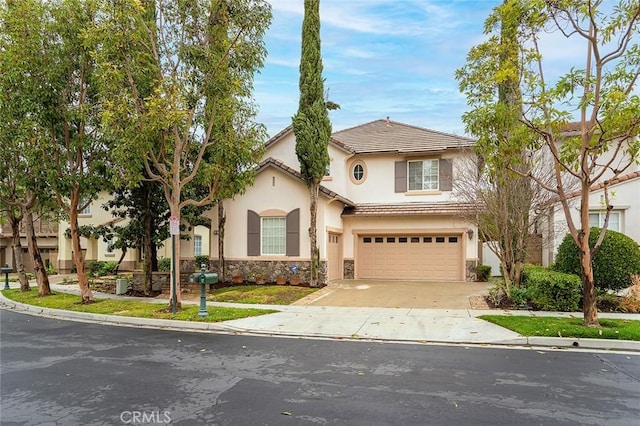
[{"left": 207, "top": 285, "right": 318, "bottom": 305}]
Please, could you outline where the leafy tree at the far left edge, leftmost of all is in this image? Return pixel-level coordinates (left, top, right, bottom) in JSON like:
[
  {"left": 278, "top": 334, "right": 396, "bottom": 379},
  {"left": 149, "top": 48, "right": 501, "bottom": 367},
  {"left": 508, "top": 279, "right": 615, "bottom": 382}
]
[{"left": 0, "top": 0, "right": 51, "bottom": 296}]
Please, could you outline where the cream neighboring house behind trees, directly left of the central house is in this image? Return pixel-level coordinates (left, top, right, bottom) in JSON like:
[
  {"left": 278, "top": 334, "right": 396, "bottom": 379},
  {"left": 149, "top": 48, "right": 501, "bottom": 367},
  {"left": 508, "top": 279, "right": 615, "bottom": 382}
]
[{"left": 57, "top": 192, "right": 210, "bottom": 273}]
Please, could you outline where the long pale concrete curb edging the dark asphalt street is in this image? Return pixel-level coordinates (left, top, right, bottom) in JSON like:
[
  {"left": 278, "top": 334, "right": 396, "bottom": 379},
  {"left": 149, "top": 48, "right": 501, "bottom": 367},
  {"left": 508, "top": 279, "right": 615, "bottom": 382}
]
[{"left": 0, "top": 293, "right": 640, "bottom": 352}]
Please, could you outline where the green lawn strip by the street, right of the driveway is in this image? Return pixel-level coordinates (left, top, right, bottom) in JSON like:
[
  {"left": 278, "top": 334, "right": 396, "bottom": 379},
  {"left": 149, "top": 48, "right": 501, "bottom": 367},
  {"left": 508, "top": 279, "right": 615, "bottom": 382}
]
[{"left": 478, "top": 315, "right": 640, "bottom": 341}]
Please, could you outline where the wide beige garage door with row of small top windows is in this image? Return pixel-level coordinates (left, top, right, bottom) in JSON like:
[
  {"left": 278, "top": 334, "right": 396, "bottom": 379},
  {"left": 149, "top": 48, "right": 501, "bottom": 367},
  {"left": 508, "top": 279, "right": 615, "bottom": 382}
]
[{"left": 356, "top": 234, "right": 463, "bottom": 281}]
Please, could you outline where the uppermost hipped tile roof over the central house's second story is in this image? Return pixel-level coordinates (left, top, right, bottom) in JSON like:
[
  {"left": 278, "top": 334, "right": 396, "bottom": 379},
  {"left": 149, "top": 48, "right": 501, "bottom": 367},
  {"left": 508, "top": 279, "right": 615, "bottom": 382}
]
[{"left": 333, "top": 118, "right": 475, "bottom": 154}]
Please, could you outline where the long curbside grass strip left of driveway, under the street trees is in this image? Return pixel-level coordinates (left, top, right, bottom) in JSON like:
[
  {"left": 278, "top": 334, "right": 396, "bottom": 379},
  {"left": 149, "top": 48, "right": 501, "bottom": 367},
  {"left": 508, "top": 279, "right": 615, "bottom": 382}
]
[{"left": 2, "top": 289, "right": 277, "bottom": 322}]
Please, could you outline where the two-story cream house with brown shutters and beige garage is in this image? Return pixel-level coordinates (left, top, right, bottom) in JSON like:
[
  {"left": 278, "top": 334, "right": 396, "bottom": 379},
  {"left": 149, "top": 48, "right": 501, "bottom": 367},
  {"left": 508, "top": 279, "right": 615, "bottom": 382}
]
[{"left": 211, "top": 119, "right": 478, "bottom": 283}]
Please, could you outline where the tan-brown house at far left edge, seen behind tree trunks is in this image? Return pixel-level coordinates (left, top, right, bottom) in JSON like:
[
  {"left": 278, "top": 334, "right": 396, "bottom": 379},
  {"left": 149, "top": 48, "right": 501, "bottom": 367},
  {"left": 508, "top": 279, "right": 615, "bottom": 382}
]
[{"left": 0, "top": 219, "right": 58, "bottom": 272}]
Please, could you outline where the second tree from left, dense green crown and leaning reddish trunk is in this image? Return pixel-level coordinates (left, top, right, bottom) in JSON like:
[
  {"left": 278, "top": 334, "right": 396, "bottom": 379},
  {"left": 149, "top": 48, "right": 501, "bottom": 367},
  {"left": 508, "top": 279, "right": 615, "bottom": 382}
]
[{"left": 39, "top": 0, "right": 109, "bottom": 303}]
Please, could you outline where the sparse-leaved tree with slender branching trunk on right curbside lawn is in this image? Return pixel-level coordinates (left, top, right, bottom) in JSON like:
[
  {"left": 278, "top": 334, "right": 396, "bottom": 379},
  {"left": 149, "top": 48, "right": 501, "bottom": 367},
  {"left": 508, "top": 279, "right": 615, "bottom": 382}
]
[{"left": 457, "top": 0, "right": 640, "bottom": 326}]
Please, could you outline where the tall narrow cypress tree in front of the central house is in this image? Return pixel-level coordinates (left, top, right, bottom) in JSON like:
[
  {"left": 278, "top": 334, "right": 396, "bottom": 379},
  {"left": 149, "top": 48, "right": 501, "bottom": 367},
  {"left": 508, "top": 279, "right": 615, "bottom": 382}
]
[{"left": 293, "top": 0, "right": 331, "bottom": 287}]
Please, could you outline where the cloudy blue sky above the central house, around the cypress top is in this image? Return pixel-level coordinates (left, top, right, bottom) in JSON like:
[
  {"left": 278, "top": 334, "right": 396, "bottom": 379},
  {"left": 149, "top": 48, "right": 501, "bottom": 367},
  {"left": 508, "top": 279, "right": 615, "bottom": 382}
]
[{"left": 254, "top": 0, "right": 501, "bottom": 136}]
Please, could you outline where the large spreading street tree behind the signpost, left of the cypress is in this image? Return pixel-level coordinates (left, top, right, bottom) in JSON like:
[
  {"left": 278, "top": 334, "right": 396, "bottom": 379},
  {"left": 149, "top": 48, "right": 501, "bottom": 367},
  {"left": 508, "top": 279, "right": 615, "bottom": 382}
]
[{"left": 92, "top": 0, "right": 271, "bottom": 306}]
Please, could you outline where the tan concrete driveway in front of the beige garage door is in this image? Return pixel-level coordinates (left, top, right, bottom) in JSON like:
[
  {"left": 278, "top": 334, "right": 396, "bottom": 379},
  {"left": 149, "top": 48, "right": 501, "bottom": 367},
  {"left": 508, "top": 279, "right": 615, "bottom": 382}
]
[{"left": 295, "top": 280, "right": 492, "bottom": 309}]
